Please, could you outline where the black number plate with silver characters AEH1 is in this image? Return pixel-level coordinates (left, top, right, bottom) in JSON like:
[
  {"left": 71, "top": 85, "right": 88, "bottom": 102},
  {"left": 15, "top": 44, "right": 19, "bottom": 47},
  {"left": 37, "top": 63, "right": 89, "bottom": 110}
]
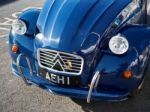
[{"left": 39, "top": 69, "right": 81, "bottom": 86}]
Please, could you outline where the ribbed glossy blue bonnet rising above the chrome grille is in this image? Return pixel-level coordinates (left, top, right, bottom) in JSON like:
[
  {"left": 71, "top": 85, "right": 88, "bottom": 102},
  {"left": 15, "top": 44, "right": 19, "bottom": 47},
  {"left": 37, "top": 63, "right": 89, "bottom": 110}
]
[{"left": 37, "top": 0, "right": 130, "bottom": 52}]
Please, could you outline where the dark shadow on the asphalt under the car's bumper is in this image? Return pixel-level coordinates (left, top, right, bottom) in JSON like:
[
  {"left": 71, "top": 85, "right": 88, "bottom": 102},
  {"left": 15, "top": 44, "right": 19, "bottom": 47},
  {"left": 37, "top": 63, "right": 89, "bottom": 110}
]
[{"left": 72, "top": 64, "right": 150, "bottom": 112}]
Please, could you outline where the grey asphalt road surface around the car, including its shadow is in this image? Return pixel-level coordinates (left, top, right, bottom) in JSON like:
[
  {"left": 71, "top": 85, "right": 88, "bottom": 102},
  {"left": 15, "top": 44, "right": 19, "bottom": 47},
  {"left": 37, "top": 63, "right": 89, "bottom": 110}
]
[{"left": 0, "top": 0, "right": 150, "bottom": 112}]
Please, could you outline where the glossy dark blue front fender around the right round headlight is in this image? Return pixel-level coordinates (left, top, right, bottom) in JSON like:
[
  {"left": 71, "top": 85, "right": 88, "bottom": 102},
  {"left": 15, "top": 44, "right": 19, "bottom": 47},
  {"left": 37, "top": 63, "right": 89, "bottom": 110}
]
[{"left": 95, "top": 25, "right": 150, "bottom": 91}]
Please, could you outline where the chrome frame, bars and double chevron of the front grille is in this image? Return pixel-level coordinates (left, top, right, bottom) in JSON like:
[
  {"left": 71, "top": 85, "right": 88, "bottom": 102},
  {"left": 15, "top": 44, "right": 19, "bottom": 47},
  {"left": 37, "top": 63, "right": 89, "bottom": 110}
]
[{"left": 37, "top": 48, "right": 84, "bottom": 76}]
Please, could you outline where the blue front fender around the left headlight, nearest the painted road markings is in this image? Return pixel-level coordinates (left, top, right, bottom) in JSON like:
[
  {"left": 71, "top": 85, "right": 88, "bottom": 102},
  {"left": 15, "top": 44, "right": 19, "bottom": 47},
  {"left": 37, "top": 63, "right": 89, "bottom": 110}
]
[{"left": 9, "top": 8, "right": 41, "bottom": 60}]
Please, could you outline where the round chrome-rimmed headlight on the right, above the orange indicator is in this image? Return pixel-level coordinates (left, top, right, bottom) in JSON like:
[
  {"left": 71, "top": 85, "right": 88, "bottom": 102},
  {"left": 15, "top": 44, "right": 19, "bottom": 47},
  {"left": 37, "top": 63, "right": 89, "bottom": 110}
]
[{"left": 109, "top": 34, "right": 129, "bottom": 55}]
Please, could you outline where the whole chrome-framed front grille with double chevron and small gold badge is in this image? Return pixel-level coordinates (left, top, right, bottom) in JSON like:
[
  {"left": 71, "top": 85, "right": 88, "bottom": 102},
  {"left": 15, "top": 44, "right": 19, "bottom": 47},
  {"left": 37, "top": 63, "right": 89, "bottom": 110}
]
[{"left": 37, "top": 48, "right": 84, "bottom": 75}]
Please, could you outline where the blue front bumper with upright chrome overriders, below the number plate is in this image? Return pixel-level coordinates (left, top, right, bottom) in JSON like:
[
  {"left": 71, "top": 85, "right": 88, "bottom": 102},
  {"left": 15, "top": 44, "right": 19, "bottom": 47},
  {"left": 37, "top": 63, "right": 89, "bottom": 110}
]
[{"left": 12, "top": 54, "right": 129, "bottom": 103}]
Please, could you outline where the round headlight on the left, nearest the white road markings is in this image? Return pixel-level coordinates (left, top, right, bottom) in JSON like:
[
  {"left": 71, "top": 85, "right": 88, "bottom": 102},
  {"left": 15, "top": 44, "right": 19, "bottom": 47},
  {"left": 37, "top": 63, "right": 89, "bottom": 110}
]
[{"left": 12, "top": 20, "right": 27, "bottom": 35}]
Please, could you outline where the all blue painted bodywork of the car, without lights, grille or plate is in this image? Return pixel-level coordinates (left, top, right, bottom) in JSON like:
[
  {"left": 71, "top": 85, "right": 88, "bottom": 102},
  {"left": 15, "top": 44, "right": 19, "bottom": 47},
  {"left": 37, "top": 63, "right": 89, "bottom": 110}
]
[{"left": 9, "top": 0, "right": 150, "bottom": 101}]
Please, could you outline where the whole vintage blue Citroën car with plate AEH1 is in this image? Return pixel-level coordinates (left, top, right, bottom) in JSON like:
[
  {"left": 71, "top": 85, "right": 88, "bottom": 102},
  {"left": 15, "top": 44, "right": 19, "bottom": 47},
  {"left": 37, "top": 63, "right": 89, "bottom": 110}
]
[{"left": 9, "top": 0, "right": 150, "bottom": 103}]
